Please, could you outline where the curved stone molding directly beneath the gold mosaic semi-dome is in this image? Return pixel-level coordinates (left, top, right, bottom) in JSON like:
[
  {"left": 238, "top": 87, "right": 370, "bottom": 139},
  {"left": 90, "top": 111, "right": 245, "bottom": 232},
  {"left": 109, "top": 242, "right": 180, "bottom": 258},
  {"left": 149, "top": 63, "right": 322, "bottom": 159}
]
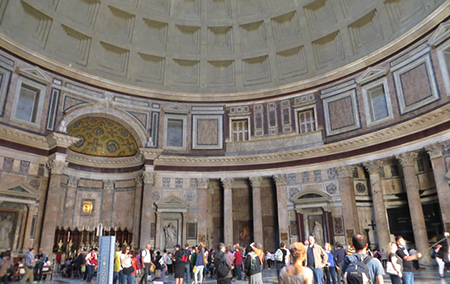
[{"left": 66, "top": 149, "right": 144, "bottom": 169}]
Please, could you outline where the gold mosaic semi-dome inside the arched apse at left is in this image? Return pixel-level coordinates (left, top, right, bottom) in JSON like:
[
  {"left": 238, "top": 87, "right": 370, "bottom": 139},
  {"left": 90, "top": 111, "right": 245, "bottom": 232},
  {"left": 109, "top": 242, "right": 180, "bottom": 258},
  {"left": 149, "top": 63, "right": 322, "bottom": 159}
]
[{"left": 67, "top": 117, "right": 137, "bottom": 157}]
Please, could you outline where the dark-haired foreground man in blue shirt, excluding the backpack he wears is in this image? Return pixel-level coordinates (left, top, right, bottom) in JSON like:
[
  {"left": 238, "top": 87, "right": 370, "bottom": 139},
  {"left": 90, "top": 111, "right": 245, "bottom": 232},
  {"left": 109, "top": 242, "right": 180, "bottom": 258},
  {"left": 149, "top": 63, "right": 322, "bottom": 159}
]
[{"left": 341, "top": 234, "right": 384, "bottom": 284}]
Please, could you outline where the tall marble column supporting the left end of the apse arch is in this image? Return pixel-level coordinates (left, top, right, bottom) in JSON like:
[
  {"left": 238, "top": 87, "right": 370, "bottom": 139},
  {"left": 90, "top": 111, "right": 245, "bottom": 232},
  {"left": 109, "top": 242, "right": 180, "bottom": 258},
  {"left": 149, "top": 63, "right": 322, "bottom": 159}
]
[{"left": 40, "top": 160, "right": 68, "bottom": 255}]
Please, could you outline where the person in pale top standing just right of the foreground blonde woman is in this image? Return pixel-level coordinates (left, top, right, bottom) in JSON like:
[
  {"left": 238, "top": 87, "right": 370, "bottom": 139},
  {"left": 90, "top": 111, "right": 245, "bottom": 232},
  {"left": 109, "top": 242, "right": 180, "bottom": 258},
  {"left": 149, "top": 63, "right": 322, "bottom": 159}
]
[{"left": 306, "top": 235, "right": 328, "bottom": 284}]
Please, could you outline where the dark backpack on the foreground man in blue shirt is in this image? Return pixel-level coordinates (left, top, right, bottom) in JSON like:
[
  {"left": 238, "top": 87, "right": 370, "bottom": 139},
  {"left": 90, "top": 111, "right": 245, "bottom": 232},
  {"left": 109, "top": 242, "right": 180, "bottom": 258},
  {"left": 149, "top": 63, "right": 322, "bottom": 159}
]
[{"left": 344, "top": 254, "right": 372, "bottom": 284}]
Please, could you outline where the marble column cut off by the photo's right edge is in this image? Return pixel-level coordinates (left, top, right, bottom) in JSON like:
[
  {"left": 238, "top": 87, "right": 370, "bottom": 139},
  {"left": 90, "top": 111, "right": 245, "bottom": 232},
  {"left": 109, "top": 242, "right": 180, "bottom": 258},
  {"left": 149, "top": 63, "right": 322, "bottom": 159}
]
[{"left": 425, "top": 143, "right": 450, "bottom": 232}]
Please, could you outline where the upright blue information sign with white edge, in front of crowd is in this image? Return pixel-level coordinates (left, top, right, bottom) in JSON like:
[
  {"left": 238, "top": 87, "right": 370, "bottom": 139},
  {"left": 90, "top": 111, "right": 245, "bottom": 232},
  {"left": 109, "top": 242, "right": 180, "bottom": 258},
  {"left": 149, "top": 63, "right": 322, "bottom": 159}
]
[{"left": 97, "top": 236, "right": 116, "bottom": 284}]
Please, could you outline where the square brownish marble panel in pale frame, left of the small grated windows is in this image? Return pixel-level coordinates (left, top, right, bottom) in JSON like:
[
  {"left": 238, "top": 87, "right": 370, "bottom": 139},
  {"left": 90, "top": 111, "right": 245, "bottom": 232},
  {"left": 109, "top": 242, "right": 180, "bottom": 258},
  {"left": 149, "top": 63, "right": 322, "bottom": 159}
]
[{"left": 192, "top": 115, "right": 223, "bottom": 150}]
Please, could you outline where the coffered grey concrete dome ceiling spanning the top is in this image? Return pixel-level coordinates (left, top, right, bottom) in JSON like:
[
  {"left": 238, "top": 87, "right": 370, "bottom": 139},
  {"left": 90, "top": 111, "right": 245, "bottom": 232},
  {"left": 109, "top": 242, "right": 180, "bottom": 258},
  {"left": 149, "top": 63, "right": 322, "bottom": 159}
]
[{"left": 0, "top": 0, "right": 444, "bottom": 101}]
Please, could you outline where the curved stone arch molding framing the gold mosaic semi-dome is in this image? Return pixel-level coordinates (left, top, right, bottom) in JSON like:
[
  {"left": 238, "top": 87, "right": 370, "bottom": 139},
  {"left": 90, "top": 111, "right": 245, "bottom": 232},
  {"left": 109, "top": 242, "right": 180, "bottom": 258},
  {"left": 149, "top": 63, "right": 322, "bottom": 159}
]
[{"left": 58, "top": 106, "right": 149, "bottom": 148}]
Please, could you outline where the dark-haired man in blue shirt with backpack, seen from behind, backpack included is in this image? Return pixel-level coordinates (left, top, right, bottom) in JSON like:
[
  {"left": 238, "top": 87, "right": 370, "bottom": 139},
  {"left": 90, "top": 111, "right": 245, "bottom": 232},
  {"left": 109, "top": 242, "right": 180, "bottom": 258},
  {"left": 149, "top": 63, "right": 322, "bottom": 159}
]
[{"left": 341, "top": 234, "right": 384, "bottom": 284}]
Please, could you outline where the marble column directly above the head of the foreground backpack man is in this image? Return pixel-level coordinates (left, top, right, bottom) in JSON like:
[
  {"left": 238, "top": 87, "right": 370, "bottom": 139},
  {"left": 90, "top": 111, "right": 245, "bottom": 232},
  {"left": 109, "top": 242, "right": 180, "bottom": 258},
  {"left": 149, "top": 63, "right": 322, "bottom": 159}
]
[{"left": 336, "top": 166, "right": 361, "bottom": 244}]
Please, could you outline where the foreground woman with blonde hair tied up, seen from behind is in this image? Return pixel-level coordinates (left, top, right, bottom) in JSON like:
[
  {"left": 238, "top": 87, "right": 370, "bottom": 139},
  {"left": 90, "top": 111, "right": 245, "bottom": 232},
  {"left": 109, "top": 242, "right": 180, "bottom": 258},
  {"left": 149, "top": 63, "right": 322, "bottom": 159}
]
[{"left": 279, "top": 243, "right": 313, "bottom": 284}]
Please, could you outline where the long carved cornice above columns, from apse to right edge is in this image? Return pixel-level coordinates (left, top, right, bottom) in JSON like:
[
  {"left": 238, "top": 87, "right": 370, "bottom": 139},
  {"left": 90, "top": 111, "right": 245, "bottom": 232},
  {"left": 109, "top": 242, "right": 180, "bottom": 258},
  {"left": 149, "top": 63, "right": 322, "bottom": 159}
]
[{"left": 154, "top": 104, "right": 450, "bottom": 167}]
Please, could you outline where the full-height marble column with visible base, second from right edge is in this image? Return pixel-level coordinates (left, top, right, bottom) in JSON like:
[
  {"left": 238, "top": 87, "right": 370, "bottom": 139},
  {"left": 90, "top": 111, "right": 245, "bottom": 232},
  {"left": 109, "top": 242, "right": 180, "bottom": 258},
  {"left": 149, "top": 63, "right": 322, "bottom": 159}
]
[{"left": 395, "top": 152, "right": 432, "bottom": 265}]
